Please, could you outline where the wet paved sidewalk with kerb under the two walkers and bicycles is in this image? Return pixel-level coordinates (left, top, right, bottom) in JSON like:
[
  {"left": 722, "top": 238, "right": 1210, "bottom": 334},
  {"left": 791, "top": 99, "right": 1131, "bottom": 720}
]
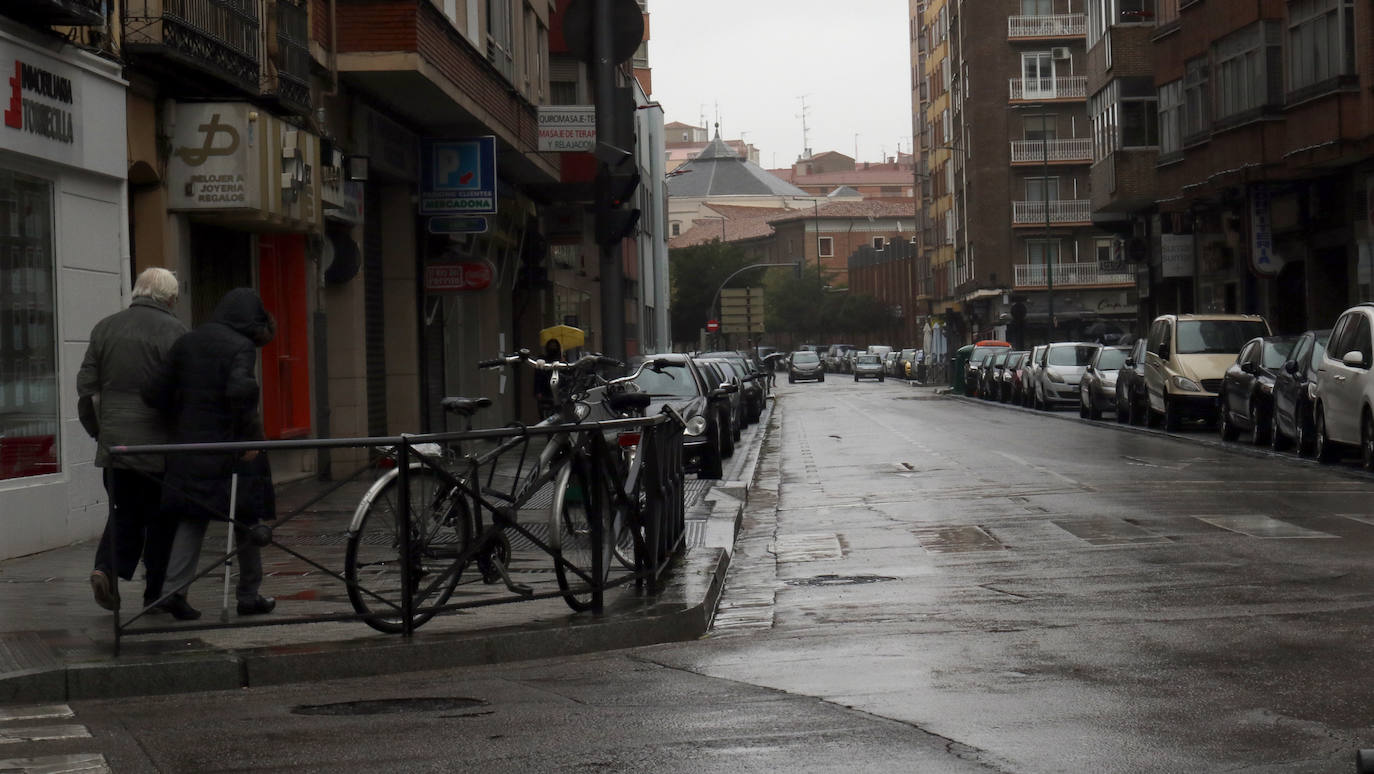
[{"left": 0, "top": 410, "right": 775, "bottom": 704}]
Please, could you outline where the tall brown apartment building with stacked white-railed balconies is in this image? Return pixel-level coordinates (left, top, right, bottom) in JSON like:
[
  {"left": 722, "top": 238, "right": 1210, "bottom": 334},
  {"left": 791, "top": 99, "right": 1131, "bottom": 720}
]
[{"left": 916, "top": 0, "right": 1136, "bottom": 345}]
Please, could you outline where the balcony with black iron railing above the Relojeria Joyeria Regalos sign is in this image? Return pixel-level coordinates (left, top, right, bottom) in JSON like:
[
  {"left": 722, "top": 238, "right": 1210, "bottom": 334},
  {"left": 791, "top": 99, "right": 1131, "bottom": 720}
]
[{"left": 124, "top": 0, "right": 261, "bottom": 95}]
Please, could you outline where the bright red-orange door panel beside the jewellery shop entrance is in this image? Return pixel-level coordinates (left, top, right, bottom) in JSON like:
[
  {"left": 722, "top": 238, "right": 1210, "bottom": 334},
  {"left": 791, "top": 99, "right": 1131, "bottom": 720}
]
[{"left": 258, "top": 234, "right": 311, "bottom": 440}]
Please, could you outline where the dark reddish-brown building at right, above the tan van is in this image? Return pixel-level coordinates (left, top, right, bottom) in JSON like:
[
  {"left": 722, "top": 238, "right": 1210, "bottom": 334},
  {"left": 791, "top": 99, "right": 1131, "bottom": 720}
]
[{"left": 1090, "top": 0, "right": 1374, "bottom": 333}]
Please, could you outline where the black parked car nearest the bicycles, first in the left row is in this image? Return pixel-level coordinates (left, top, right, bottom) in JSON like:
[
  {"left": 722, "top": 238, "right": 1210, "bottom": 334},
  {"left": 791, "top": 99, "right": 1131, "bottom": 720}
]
[{"left": 635, "top": 353, "right": 730, "bottom": 478}]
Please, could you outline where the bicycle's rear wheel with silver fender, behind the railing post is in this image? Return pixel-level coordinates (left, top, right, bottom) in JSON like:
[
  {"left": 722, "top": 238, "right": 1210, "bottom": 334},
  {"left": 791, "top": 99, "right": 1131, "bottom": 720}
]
[{"left": 344, "top": 466, "right": 473, "bottom": 634}]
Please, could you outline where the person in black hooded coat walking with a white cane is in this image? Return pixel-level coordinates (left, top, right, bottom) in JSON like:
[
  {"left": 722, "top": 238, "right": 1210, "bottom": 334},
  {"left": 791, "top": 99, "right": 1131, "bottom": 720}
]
[{"left": 144, "top": 287, "right": 276, "bottom": 620}]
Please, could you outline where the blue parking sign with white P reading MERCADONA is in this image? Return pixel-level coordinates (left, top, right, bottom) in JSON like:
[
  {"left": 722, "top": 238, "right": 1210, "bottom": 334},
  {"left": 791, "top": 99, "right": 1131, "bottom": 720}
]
[{"left": 420, "top": 136, "right": 496, "bottom": 214}]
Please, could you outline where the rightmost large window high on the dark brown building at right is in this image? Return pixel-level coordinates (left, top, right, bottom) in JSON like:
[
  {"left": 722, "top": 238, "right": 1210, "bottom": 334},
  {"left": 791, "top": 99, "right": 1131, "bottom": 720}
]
[{"left": 1287, "top": 0, "right": 1355, "bottom": 92}]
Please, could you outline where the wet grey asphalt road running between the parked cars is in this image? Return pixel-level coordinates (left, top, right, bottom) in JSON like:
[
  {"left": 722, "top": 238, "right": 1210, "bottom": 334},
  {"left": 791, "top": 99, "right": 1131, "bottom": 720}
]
[{"left": 8, "top": 378, "right": 1374, "bottom": 773}]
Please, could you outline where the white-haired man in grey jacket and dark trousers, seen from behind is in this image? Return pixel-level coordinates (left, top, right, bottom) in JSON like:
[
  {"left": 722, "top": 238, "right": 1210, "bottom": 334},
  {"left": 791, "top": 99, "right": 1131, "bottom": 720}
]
[{"left": 77, "top": 268, "right": 185, "bottom": 610}]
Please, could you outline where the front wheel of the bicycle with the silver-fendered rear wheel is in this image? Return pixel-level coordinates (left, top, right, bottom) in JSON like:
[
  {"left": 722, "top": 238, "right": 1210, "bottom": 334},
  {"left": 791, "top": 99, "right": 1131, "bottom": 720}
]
[{"left": 548, "top": 456, "right": 611, "bottom": 613}]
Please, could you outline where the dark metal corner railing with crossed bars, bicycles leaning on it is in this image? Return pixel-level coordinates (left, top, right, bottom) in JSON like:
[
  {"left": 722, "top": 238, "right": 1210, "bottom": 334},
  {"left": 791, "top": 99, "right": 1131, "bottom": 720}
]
[{"left": 110, "top": 411, "right": 686, "bottom": 654}]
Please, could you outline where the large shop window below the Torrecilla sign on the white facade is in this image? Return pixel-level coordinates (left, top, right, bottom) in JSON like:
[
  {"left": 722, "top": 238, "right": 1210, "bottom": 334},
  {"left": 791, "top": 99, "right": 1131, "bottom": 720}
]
[{"left": 0, "top": 170, "right": 60, "bottom": 481}]
